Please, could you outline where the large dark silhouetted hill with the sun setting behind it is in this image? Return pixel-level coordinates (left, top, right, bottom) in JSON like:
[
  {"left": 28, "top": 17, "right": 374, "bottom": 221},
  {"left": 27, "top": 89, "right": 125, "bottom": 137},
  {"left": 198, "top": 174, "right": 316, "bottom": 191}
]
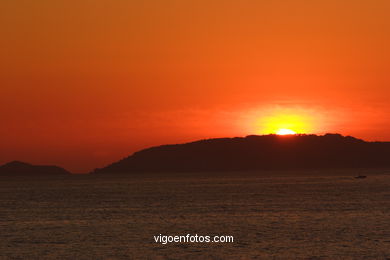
[{"left": 94, "top": 134, "right": 390, "bottom": 173}]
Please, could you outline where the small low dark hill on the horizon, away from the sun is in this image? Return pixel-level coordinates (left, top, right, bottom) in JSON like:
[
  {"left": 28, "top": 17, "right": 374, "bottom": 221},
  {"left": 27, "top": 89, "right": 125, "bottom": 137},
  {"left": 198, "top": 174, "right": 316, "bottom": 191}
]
[{"left": 0, "top": 161, "right": 70, "bottom": 176}]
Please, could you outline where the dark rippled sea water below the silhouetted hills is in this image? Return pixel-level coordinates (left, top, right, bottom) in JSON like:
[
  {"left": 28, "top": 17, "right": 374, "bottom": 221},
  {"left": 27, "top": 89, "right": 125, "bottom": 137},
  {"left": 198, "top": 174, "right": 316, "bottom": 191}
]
[{"left": 0, "top": 172, "right": 390, "bottom": 259}]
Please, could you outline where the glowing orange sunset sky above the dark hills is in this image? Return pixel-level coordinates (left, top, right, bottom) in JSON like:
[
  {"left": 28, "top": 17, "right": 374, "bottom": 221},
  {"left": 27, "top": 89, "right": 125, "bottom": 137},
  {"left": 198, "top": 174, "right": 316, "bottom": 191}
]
[{"left": 0, "top": 0, "right": 390, "bottom": 172}]
